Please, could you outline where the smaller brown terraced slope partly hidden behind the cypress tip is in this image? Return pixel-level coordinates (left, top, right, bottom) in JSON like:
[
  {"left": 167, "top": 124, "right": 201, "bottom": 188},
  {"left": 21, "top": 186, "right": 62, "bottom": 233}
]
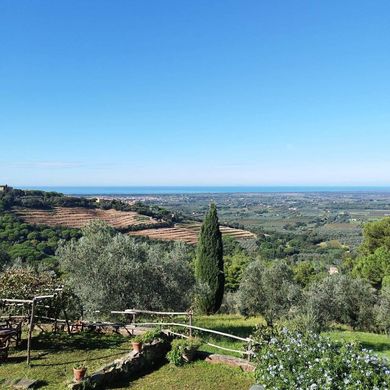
[{"left": 129, "top": 223, "right": 256, "bottom": 244}]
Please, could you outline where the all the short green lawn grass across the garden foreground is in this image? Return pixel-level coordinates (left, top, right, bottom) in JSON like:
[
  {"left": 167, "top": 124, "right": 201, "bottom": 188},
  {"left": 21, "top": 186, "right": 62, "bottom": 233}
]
[{"left": 0, "top": 315, "right": 390, "bottom": 390}]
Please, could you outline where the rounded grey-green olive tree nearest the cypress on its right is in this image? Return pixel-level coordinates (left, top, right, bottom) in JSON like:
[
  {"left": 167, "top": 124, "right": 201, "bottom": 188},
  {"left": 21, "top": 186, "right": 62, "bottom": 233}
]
[{"left": 239, "top": 260, "right": 300, "bottom": 325}]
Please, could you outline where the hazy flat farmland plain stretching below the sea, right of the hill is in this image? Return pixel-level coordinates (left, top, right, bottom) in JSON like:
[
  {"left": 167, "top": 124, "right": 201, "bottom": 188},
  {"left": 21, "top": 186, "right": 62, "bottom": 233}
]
[{"left": 122, "top": 191, "right": 390, "bottom": 250}]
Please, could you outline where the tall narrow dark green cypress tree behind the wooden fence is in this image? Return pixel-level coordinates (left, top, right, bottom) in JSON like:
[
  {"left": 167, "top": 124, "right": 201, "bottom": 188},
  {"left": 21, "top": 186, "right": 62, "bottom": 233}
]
[{"left": 195, "top": 203, "right": 225, "bottom": 314}]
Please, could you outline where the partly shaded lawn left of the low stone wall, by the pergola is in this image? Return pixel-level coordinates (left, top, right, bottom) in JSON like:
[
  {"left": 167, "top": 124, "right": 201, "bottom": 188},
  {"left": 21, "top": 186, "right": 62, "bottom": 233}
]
[{"left": 0, "top": 333, "right": 130, "bottom": 390}]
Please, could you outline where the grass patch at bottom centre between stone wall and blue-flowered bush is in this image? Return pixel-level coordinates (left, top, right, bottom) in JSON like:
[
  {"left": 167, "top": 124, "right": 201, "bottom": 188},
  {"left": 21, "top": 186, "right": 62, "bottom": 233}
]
[{"left": 112, "top": 361, "right": 254, "bottom": 390}]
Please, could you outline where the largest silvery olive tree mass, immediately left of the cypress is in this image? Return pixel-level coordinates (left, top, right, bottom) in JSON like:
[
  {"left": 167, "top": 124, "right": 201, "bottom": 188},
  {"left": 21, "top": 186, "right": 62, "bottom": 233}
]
[{"left": 57, "top": 221, "right": 193, "bottom": 316}]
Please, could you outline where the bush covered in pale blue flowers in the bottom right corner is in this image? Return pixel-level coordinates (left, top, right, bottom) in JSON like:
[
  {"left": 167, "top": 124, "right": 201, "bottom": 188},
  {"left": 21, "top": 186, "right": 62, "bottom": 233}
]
[{"left": 254, "top": 328, "right": 390, "bottom": 390}]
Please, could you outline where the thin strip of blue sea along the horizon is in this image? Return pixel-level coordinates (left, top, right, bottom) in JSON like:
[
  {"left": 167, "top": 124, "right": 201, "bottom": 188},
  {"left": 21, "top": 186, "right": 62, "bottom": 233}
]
[{"left": 20, "top": 186, "right": 390, "bottom": 196}]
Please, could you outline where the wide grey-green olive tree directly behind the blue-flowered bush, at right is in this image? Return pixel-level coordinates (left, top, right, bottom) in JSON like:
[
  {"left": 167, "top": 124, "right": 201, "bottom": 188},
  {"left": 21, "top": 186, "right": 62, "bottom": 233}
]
[{"left": 302, "top": 274, "right": 375, "bottom": 330}]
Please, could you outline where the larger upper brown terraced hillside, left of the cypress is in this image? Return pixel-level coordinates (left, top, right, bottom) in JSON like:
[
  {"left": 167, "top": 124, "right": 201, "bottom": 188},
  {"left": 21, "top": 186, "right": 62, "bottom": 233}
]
[{"left": 14, "top": 207, "right": 158, "bottom": 229}]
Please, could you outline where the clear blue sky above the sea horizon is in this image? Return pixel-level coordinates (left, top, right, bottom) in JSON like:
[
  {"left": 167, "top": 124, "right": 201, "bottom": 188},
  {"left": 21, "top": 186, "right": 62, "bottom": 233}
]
[{"left": 0, "top": 0, "right": 390, "bottom": 186}]
